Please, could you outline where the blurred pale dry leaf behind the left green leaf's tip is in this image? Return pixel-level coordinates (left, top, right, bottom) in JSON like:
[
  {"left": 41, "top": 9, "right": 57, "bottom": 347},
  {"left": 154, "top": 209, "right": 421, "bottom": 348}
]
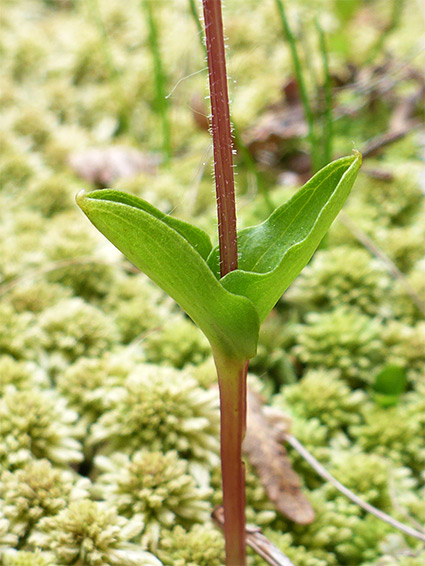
[{"left": 69, "top": 146, "right": 160, "bottom": 186}]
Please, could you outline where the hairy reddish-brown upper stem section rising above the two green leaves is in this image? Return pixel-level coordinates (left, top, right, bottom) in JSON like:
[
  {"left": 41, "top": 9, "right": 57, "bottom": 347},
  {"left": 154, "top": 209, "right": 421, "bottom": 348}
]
[{"left": 203, "top": 0, "right": 238, "bottom": 277}]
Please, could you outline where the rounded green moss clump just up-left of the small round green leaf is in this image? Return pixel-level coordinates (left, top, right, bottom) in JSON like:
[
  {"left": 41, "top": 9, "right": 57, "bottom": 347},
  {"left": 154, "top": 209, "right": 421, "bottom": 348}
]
[{"left": 292, "top": 306, "right": 385, "bottom": 386}]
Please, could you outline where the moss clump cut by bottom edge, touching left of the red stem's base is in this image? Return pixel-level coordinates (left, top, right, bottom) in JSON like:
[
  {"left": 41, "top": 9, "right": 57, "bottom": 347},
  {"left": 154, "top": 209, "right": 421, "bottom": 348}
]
[{"left": 158, "top": 525, "right": 224, "bottom": 566}]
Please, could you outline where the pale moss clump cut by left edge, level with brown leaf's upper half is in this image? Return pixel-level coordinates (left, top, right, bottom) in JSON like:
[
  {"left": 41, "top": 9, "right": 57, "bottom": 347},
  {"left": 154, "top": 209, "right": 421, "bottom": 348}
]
[{"left": 0, "top": 389, "right": 82, "bottom": 470}]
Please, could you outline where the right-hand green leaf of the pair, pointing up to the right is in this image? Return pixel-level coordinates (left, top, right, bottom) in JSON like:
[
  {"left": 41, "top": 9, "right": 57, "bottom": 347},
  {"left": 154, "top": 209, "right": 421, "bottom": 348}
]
[{"left": 219, "top": 152, "right": 361, "bottom": 322}]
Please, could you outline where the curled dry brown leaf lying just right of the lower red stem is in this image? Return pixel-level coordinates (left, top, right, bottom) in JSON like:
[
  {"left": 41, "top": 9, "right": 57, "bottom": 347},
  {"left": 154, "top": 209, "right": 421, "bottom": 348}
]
[{"left": 243, "top": 390, "right": 314, "bottom": 525}]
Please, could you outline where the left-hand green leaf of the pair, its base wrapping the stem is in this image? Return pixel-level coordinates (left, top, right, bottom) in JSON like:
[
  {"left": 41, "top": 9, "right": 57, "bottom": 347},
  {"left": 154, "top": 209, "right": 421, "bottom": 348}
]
[{"left": 77, "top": 190, "right": 259, "bottom": 359}]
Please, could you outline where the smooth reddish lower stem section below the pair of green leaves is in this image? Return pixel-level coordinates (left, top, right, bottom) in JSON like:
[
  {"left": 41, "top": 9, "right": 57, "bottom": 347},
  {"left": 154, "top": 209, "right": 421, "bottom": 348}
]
[{"left": 214, "top": 354, "right": 249, "bottom": 566}]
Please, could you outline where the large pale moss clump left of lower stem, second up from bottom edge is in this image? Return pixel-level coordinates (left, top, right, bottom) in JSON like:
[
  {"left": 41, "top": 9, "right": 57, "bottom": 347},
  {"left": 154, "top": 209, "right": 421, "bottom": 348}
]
[{"left": 95, "top": 450, "right": 211, "bottom": 545}]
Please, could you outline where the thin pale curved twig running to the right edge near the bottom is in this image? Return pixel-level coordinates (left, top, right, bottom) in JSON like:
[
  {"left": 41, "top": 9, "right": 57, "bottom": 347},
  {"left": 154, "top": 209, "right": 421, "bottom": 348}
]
[{"left": 282, "top": 433, "right": 425, "bottom": 542}]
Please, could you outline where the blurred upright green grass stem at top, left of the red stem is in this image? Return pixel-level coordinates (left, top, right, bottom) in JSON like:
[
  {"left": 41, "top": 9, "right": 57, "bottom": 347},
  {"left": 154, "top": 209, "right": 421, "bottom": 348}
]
[{"left": 143, "top": 0, "right": 171, "bottom": 162}]
